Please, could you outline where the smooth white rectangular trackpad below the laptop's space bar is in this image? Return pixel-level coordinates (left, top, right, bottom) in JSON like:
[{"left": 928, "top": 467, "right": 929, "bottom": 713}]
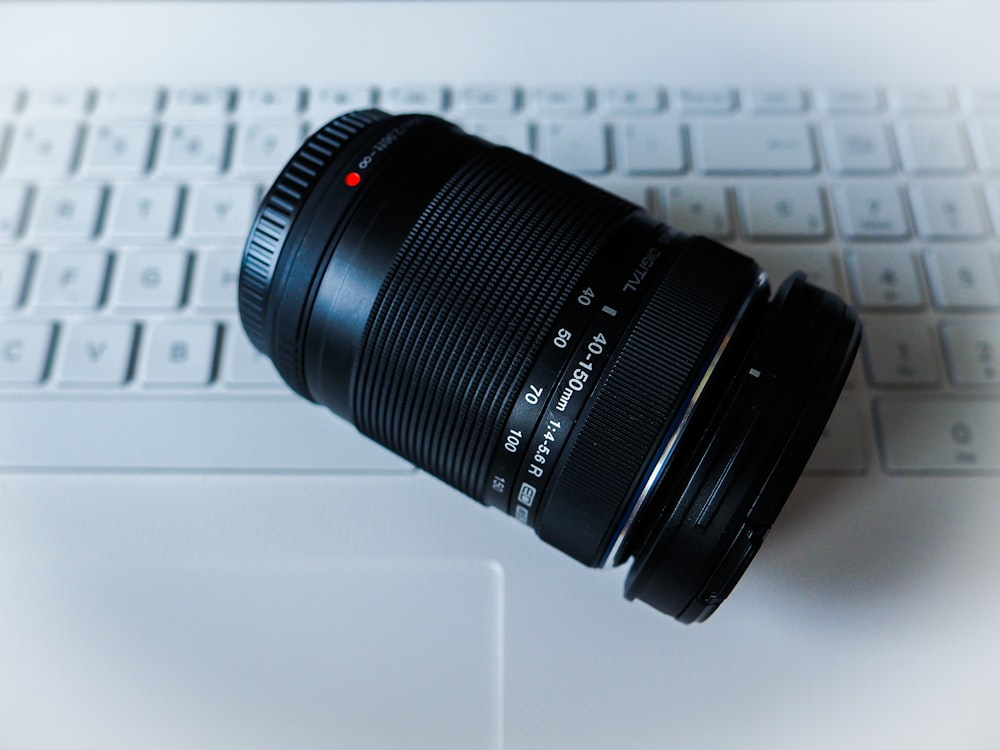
[{"left": 0, "top": 560, "right": 503, "bottom": 750}]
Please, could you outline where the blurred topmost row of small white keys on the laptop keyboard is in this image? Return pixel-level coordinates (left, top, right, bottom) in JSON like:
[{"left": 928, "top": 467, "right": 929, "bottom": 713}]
[{"left": 0, "top": 85, "right": 1000, "bottom": 118}]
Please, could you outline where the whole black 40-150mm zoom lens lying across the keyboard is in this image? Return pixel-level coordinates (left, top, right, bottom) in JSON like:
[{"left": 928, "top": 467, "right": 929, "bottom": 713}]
[{"left": 239, "top": 110, "right": 860, "bottom": 622}]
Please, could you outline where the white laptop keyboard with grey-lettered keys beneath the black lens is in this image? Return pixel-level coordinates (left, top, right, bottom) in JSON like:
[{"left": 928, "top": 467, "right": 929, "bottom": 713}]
[{"left": 0, "top": 86, "right": 1000, "bottom": 474}]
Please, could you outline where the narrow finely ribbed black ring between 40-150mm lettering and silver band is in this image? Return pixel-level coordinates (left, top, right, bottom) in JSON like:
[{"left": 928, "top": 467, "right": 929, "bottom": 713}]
[{"left": 536, "top": 238, "right": 759, "bottom": 566}]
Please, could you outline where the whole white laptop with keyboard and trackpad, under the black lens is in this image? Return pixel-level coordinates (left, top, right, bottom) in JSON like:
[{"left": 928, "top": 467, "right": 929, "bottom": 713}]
[{"left": 0, "top": 0, "right": 1000, "bottom": 750}]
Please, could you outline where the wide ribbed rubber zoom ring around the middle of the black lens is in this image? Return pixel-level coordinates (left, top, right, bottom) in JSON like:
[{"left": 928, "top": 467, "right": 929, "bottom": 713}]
[{"left": 354, "top": 148, "right": 636, "bottom": 497}]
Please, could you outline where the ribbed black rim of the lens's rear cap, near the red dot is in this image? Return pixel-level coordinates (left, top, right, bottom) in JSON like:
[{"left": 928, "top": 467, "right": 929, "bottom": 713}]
[{"left": 239, "top": 110, "right": 388, "bottom": 362}]
